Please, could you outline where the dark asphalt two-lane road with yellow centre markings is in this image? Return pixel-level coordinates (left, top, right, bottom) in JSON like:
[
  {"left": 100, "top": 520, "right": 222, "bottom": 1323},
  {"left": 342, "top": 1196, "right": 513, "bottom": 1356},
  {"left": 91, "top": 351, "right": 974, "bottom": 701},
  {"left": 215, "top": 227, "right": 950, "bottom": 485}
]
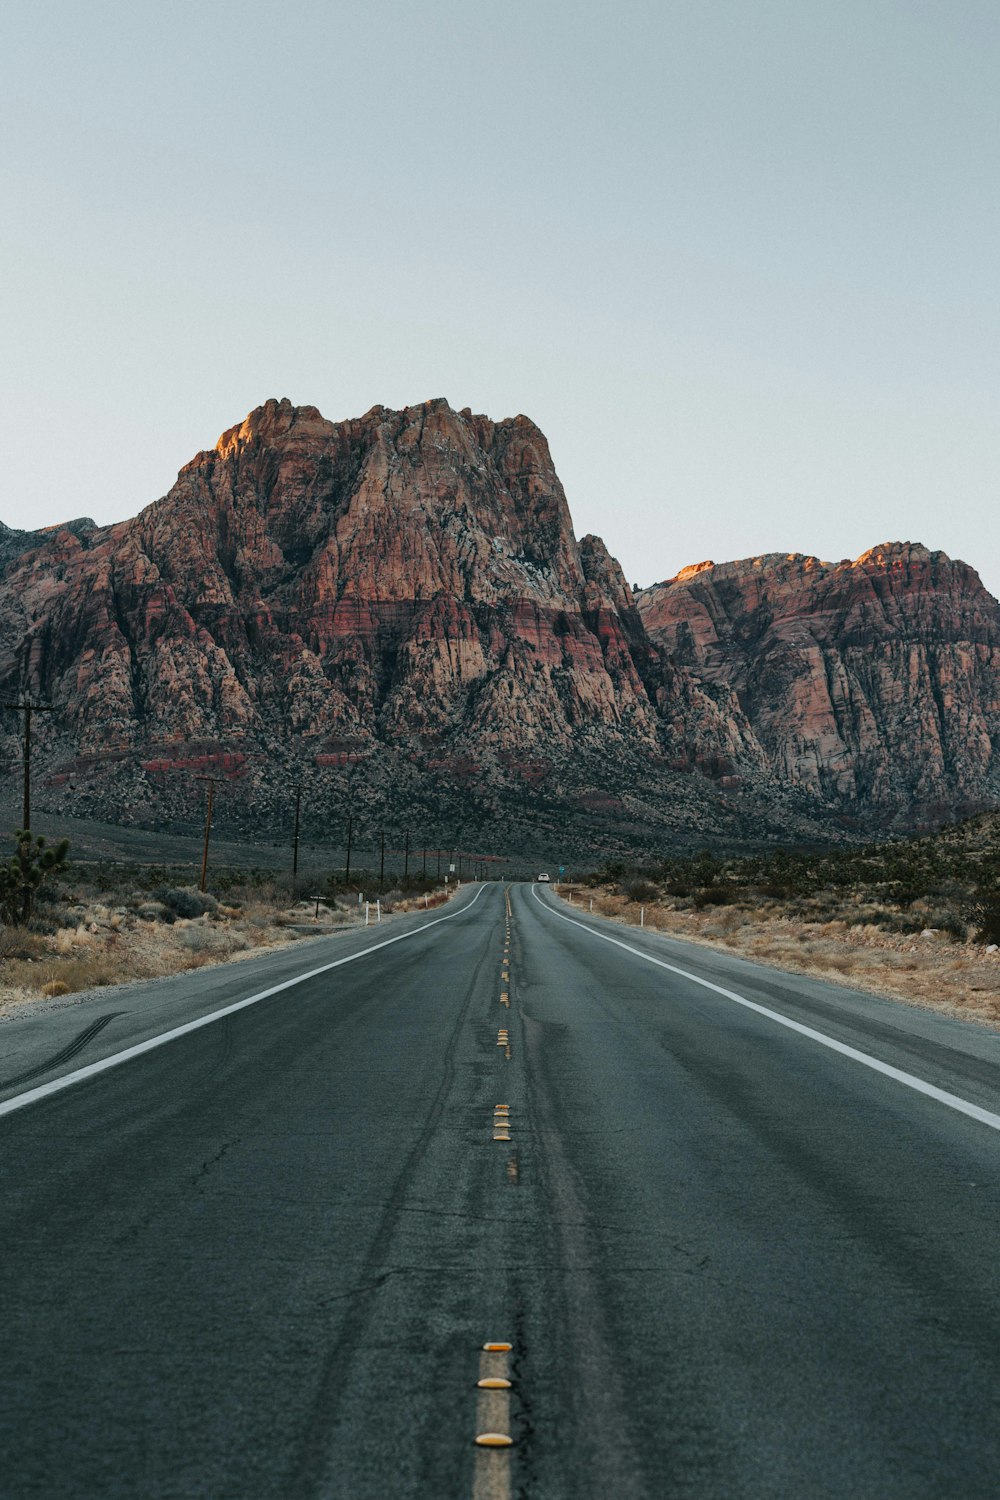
[{"left": 0, "top": 885, "right": 1000, "bottom": 1500}]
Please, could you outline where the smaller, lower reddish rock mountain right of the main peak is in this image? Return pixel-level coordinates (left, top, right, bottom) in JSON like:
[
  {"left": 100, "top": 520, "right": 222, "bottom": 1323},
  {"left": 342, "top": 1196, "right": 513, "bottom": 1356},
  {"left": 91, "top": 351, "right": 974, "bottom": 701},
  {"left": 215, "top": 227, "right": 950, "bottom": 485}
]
[{"left": 637, "top": 543, "right": 1000, "bottom": 819}]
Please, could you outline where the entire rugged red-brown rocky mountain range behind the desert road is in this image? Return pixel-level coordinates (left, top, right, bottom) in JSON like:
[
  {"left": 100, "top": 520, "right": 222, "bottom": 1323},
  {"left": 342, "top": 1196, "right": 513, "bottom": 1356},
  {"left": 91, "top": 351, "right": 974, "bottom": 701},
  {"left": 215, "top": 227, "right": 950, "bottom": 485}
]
[{"left": 0, "top": 401, "right": 1000, "bottom": 852}]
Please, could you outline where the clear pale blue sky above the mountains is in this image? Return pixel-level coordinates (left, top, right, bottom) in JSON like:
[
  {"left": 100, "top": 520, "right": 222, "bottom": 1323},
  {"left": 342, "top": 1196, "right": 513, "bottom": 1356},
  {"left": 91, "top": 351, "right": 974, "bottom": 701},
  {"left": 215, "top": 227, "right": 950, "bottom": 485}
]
[{"left": 0, "top": 0, "right": 1000, "bottom": 593}]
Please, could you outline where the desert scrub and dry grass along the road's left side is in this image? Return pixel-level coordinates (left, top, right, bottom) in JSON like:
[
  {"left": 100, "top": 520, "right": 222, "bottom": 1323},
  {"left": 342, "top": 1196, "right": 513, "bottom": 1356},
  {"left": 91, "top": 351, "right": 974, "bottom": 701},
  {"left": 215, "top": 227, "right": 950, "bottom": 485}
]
[{"left": 0, "top": 834, "right": 448, "bottom": 1014}]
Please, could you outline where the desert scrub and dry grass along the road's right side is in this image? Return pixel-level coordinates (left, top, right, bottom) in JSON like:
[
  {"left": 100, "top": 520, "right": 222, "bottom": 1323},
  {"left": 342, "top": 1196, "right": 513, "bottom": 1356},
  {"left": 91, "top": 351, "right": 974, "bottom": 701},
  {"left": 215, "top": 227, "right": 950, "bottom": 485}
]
[{"left": 571, "top": 813, "right": 1000, "bottom": 1023}]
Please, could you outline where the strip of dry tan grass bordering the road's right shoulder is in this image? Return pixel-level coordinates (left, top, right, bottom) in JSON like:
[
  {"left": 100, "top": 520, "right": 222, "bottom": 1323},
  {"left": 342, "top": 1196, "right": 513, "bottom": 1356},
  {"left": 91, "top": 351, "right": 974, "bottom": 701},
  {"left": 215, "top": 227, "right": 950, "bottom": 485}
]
[{"left": 561, "top": 887, "right": 1000, "bottom": 1025}]
